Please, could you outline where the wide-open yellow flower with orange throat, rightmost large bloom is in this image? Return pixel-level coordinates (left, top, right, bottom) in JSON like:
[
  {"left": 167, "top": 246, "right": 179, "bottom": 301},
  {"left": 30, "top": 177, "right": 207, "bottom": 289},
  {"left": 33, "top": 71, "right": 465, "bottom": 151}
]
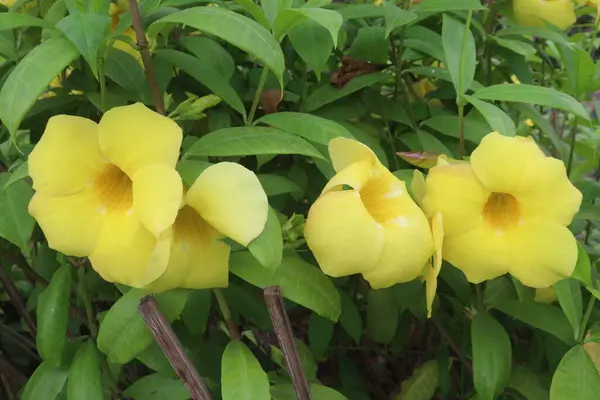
[{"left": 423, "top": 132, "right": 582, "bottom": 288}]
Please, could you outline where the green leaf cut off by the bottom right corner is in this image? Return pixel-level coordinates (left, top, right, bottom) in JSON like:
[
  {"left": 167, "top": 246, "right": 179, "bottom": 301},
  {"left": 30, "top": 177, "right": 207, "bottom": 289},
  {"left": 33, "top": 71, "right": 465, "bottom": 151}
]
[{"left": 550, "top": 345, "right": 600, "bottom": 400}]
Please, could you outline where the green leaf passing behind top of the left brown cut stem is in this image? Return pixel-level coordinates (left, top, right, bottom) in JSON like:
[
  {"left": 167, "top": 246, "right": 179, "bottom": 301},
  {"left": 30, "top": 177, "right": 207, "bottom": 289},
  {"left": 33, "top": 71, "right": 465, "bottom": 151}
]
[{"left": 98, "top": 289, "right": 189, "bottom": 364}]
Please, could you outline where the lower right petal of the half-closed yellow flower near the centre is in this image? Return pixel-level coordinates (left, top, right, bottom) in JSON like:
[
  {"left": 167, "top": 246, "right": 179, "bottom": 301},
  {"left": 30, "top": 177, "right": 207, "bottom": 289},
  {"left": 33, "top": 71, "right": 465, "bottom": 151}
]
[{"left": 363, "top": 208, "right": 433, "bottom": 289}]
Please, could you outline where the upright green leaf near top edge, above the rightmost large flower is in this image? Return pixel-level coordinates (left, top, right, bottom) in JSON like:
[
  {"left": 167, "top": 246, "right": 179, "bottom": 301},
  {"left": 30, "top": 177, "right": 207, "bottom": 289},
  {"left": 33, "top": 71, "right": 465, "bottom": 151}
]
[{"left": 442, "top": 14, "right": 477, "bottom": 95}]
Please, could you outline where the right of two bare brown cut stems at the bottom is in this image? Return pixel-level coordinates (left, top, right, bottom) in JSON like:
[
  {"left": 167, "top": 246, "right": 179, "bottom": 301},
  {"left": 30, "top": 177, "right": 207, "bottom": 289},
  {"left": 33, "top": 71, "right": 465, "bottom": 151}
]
[{"left": 263, "top": 286, "right": 310, "bottom": 400}]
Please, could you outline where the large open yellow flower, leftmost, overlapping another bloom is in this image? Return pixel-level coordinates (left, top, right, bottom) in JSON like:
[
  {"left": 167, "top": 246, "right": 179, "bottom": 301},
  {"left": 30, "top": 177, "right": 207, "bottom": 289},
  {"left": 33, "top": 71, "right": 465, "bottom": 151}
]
[{"left": 29, "top": 103, "right": 183, "bottom": 287}]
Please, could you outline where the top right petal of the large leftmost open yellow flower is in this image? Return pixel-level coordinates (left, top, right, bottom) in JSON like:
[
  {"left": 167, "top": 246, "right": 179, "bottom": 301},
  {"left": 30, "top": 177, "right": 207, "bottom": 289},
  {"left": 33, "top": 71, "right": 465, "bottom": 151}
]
[{"left": 98, "top": 103, "right": 182, "bottom": 176}]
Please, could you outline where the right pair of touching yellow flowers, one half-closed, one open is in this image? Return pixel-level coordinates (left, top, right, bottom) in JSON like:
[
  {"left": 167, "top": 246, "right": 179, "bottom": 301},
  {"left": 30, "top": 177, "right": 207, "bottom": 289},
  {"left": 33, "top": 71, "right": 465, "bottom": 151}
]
[{"left": 305, "top": 132, "right": 582, "bottom": 318}]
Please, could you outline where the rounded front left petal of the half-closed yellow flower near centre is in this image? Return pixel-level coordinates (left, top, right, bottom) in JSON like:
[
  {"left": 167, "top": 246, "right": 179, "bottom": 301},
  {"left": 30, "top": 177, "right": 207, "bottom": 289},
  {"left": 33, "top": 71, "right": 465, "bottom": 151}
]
[{"left": 304, "top": 190, "right": 384, "bottom": 277}]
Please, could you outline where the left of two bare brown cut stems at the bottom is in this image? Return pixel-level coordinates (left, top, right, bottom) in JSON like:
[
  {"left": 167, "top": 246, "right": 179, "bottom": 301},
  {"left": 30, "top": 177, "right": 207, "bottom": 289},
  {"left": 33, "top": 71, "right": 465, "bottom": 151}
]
[{"left": 138, "top": 296, "right": 212, "bottom": 400}]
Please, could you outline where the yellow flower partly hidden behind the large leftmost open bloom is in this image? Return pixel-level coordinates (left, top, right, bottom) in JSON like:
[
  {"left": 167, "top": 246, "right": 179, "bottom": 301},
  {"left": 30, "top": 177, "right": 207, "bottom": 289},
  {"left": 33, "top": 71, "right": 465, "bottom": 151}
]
[{"left": 148, "top": 162, "right": 269, "bottom": 292}]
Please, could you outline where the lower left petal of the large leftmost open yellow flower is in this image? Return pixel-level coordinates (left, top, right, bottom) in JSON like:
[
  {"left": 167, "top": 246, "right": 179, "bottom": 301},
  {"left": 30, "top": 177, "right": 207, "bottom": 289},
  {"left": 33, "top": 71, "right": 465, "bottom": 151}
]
[{"left": 29, "top": 191, "right": 102, "bottom": 257}]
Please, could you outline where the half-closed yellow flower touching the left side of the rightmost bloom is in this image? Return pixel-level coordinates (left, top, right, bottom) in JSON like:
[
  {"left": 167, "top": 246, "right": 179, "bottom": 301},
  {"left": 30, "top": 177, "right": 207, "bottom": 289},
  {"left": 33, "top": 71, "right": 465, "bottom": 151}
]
[{"left": 304, "top": 138, "right": 433, "bottom": 289}]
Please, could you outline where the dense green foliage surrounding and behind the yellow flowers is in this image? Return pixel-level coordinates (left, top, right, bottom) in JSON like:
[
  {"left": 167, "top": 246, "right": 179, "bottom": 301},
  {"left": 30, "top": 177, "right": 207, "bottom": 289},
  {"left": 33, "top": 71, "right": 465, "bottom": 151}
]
[{"left": 0, "top": 0, "right": 600, "bottom": 400}]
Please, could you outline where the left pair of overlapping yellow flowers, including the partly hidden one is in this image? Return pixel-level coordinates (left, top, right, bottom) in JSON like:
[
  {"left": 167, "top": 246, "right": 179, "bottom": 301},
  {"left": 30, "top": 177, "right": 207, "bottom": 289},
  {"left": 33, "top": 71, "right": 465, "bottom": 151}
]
[{"left": 29, "top": 103, "right": 268, "bottom": 292}]
